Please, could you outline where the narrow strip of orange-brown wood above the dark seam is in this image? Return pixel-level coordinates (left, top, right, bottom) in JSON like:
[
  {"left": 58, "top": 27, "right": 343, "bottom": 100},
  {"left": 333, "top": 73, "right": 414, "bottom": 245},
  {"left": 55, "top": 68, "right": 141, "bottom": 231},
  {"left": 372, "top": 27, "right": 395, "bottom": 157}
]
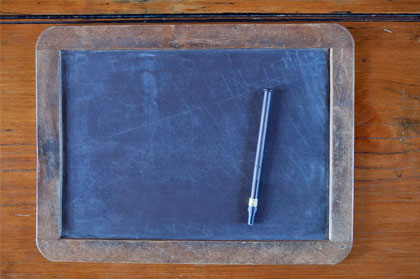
[{"left": 1, "top": 0, "right": 420, "bottom": 15}]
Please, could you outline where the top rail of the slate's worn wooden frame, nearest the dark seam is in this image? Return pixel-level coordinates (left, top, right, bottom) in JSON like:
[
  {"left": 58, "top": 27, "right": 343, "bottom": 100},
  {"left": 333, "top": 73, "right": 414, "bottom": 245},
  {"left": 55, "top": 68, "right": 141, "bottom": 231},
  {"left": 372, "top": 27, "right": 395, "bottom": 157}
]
[{"left": 36, "top": 24, "right": 354, "bottom": 50}]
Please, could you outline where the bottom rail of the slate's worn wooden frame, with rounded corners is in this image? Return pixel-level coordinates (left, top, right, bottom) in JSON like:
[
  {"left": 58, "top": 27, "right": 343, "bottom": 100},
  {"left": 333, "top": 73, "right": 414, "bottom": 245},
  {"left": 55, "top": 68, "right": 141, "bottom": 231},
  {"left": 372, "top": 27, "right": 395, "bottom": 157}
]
[{"left": 37, "top": 239, "right": 352, "bottom": 265}]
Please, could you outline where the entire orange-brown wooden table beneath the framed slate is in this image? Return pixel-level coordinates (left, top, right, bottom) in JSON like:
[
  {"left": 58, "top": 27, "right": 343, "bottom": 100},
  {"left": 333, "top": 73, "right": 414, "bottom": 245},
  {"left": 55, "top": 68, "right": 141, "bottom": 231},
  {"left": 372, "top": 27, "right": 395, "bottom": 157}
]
[{"left": 0, "top": 0, "right": 420, "bottom": 278}]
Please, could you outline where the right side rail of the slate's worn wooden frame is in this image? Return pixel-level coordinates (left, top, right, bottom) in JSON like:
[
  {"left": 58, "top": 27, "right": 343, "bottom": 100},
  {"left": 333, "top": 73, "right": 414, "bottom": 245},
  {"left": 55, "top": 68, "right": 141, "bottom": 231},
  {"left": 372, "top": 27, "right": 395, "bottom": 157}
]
[{"left": 329, "top": 47, "right": 354, "bottom": 243}]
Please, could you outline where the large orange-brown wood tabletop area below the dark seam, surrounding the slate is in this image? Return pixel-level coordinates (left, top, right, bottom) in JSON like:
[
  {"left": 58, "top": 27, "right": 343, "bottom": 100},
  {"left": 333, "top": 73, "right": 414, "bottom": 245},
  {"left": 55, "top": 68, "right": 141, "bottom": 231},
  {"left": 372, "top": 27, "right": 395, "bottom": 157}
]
[{"left": 0, "top": 20, "right": 420, "bottom": 278}]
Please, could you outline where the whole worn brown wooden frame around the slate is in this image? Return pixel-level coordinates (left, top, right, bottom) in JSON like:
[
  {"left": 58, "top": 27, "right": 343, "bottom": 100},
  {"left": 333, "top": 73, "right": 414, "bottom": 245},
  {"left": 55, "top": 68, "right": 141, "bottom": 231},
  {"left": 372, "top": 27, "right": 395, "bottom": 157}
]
[{"left": 36, "top": 24, "right": 354, "bottom": 264}]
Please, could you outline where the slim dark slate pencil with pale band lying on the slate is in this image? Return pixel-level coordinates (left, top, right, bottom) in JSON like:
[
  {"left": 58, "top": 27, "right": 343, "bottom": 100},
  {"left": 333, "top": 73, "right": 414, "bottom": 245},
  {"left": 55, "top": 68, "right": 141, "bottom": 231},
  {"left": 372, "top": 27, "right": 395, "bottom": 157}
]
[{"left": 248, "top": 89, "right": 273, "bottom": 225}]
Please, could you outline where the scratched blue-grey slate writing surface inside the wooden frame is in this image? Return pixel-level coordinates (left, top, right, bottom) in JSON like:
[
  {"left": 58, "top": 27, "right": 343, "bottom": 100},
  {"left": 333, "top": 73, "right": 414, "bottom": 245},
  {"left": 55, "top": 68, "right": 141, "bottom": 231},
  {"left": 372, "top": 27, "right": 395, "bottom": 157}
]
[{"left": 62, "top": 49, "right": 329, "bottom": 240}]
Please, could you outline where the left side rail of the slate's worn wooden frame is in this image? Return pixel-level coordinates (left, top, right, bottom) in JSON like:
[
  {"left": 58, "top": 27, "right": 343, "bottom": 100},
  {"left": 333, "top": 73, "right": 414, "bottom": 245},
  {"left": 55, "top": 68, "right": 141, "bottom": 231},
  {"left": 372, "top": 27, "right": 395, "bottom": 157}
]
[{"left": 36, "top": 50, "right": 62, "bottom": 238}]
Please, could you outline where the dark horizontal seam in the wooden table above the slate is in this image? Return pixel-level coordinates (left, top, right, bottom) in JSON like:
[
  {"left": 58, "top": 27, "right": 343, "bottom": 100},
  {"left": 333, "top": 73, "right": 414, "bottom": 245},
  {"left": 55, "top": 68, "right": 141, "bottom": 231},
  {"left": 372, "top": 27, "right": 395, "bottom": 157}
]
[{"left": 0, "top": 12, "right": 420, "bottom": 24}]
